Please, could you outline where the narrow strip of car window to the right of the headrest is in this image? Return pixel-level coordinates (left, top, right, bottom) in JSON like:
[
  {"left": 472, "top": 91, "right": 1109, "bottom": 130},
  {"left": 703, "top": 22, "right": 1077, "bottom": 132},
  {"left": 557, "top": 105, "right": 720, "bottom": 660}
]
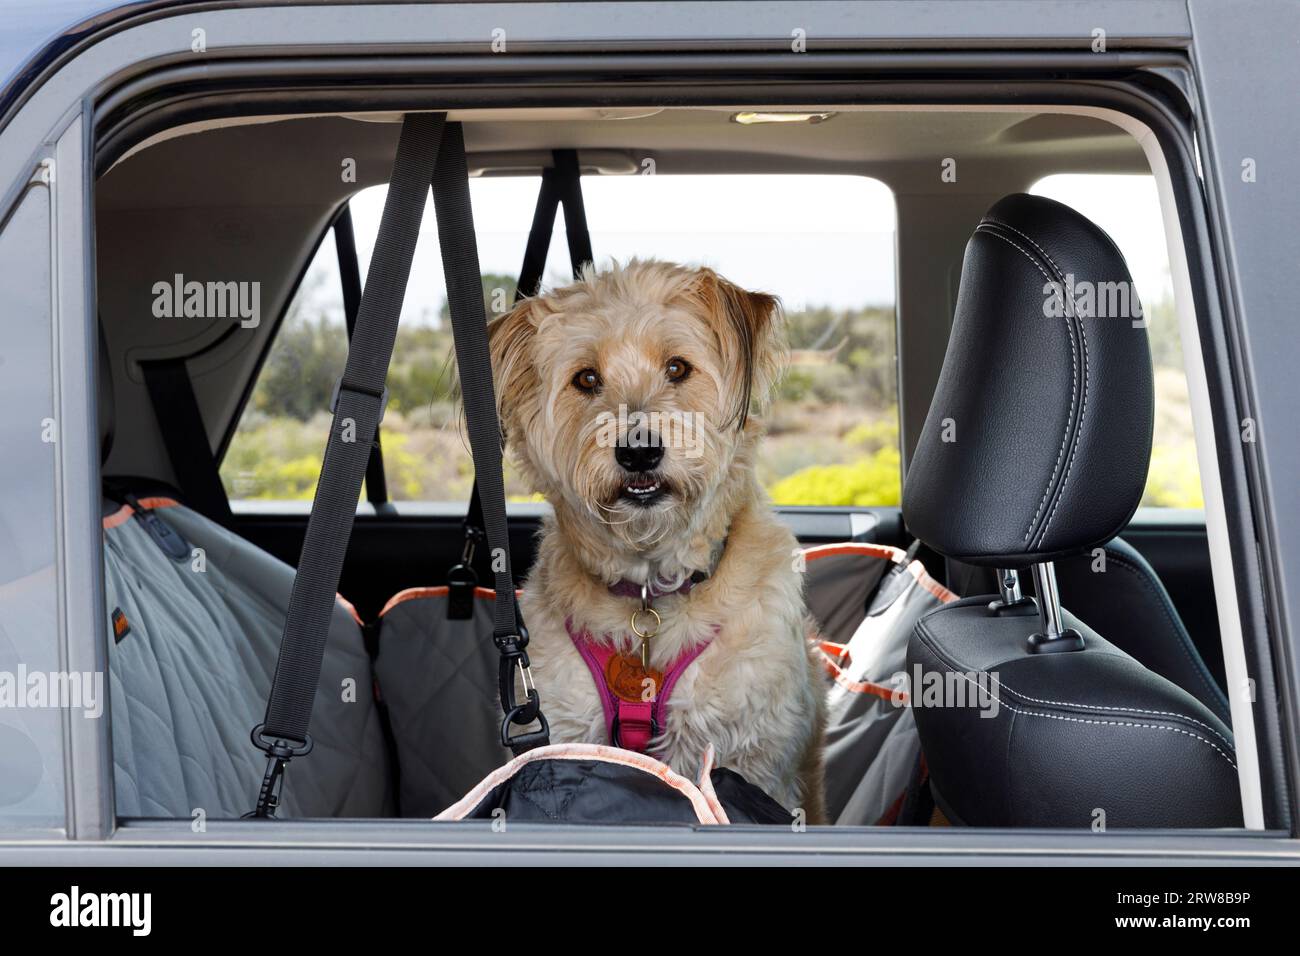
[{"left": 1031, "top": 174, "right": 1205, "bottom": 509}]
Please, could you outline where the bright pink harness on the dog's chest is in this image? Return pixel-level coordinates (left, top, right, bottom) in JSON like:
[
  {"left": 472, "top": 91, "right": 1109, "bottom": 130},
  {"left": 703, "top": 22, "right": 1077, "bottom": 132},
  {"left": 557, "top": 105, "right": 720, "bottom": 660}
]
[{"left": 564, "top": 620, "right": 718, "bottom": 753}]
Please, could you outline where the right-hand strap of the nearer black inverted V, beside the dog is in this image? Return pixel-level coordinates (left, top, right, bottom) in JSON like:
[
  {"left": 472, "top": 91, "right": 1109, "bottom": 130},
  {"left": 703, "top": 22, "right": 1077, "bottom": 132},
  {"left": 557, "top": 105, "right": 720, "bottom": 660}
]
[{"left": 433, "top": 122, "right": 550, "bottom": 756}]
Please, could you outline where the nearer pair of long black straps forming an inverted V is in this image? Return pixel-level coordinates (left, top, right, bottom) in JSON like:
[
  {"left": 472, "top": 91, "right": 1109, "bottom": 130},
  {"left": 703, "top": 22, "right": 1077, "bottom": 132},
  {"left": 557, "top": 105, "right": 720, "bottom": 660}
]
[{"left": 250, "top": 113, "right": 549, "bottom": 817}]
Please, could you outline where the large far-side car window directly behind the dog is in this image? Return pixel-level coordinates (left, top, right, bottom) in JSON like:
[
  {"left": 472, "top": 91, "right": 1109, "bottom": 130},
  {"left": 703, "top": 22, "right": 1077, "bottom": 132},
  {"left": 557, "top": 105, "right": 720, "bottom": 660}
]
[{"left": 221, "top": 174, "right": 900, "bottom": 506}]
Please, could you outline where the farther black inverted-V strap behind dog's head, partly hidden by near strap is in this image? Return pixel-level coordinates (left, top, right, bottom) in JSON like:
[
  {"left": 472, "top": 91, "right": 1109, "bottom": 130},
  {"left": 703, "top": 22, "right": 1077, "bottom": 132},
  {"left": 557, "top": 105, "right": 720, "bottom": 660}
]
[{"left": 447, "top": 150, "right": 594, "bottom": 620}]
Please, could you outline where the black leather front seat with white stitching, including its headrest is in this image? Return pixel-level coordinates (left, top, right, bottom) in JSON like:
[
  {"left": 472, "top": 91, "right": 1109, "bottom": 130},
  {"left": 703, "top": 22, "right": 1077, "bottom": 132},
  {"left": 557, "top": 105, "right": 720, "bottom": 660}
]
[{"left": 904, "top": 195, "right": 1242, "bottom": 827}]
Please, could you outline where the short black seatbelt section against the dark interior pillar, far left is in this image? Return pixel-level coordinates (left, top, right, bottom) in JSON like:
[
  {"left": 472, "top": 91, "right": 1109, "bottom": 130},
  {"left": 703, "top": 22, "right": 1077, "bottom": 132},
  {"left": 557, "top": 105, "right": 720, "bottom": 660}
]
[{"left": 140, "top": 359, "right": 234, "bottom": 528}]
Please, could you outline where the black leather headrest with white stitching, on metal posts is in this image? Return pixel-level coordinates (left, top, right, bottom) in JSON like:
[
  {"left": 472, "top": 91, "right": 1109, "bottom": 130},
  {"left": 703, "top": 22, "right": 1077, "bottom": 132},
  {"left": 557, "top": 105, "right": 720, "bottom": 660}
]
[{"left": 902, "top": 194, "right": 1153, "bottom": 567}]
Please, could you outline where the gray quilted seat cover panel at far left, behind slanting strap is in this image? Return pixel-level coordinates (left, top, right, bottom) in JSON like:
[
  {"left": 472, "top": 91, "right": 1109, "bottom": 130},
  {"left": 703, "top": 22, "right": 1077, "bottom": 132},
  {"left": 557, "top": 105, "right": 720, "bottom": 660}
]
[{"left": 104, "top": 499, "right": 393, "bottom": 819}]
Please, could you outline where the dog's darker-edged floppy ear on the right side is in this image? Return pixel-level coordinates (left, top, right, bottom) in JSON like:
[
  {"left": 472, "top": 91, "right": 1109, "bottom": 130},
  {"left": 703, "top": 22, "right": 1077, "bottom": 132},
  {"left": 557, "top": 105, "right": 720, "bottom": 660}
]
[{"left": 692, "top": 269, "right": 788, "bottom": 428}]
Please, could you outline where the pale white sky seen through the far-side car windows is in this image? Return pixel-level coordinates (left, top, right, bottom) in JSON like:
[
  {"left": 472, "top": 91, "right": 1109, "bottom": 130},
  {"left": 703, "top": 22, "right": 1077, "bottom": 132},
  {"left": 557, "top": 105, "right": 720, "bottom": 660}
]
[{"left": 308, "top": 174, "right": 1171, "bottom": 323}]
